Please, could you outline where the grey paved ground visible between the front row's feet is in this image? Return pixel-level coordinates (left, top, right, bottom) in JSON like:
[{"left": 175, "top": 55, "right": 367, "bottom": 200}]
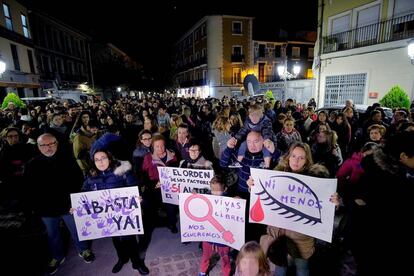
[{"left": 50, "top": 224, "right": 355, "bottom": 276}]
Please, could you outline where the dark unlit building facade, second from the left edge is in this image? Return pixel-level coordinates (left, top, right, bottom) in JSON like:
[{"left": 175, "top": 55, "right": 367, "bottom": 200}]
[{"left": 30, "top": 11, "right": 93, "bottom": 89}]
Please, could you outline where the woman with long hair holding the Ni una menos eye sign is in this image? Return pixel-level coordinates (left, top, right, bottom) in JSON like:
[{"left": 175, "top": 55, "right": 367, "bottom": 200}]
[{"left": 247, "top": 142, "right": 338, "bottom": 276}]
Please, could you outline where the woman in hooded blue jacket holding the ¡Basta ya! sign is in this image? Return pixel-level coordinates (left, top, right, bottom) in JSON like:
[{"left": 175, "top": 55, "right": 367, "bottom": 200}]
[{"left": 82, "top": 150, "right": 149, "bottom": 275}]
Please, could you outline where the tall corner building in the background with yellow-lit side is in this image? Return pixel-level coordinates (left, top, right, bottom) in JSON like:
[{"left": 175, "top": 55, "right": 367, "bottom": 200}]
[{"left": 175, "top": 15, "right": 254, "bottom": 98}]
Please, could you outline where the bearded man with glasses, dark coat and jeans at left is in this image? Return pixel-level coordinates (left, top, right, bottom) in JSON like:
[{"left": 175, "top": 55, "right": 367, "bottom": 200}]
[{"left": 25, "top": 133, "right": 95, "bottom": 274}]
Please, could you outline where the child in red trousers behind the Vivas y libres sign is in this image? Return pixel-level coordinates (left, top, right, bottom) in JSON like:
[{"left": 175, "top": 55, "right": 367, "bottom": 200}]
[{"left": 198, "top": 175, "right": 231, "bottom": 276}]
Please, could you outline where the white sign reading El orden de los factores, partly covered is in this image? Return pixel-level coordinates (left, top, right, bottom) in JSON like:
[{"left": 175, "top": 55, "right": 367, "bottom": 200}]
[{"left": 158, "top": 167, "right": 214, "bottom": 205}]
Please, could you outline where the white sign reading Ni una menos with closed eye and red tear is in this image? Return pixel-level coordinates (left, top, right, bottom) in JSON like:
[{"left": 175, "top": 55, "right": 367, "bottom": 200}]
[{"left": 249, "top": 169, "right": 337, "bottom": 242}]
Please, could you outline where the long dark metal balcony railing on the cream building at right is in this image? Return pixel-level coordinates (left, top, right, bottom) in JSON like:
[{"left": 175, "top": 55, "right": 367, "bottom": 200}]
[{"left": 323, "top": 13, "right": 414, "bottom": 54}]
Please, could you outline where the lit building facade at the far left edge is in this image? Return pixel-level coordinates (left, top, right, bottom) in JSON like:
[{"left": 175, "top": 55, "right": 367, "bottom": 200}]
[{"left": 0, "top": 0, "right": 40, "bottom": 102}]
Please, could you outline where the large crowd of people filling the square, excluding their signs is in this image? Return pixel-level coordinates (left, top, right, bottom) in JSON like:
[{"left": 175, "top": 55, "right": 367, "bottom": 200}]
[{"left": 0, "top": 94, "right": 414, "bottom": 276}]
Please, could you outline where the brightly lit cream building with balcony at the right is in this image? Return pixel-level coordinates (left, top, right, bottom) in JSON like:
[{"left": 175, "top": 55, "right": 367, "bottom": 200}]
[{"left": 314, "top": 0, "right": 414, "bottom": 106}]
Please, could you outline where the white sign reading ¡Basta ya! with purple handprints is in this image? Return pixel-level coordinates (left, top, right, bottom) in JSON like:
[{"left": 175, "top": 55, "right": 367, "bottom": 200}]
[{"left": 70, "top": 187, "right": 144, "bottom": 241}]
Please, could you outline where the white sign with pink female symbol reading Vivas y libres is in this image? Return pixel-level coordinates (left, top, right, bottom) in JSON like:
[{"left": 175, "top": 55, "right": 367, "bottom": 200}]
[{"left": 179, "top": 193, "right": 246, "bottom": 250}]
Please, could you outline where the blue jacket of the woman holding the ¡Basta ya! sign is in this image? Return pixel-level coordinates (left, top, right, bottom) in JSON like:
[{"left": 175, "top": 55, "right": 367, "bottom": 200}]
[{"left": 82, "top": 161, "right": 137, "bottom": 191}]
